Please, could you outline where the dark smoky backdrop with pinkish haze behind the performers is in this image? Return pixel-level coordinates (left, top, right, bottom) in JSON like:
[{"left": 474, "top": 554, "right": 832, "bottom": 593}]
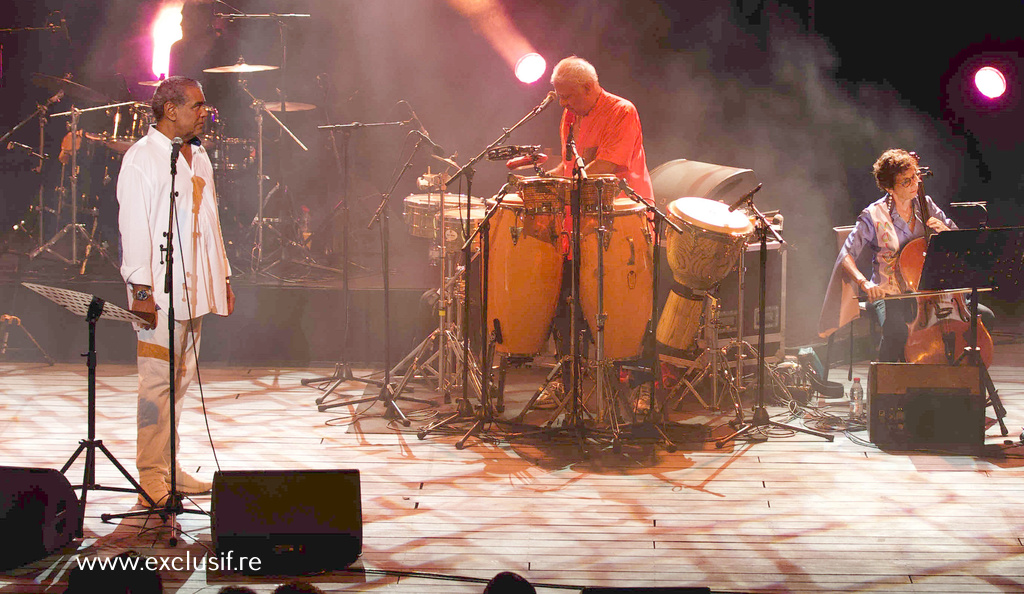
[{"left": 0, "top": 0, "right": 1024, "bottom": 345}]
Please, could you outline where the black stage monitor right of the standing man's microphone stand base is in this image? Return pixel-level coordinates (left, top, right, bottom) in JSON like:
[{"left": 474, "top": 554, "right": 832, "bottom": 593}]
[{"left": 211, "top": 470, "right": 362, "bottom": 575}]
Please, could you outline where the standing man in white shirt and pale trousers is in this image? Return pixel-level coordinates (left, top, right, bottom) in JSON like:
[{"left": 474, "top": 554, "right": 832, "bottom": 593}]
[{"left": 118, "top": 77, "right": 234, "bottom": 504}]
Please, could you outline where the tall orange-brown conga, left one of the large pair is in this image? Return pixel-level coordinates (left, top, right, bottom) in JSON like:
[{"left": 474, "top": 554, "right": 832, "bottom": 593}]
[{"left": 487, "top": 192, "right": 562, "bottom": 355}]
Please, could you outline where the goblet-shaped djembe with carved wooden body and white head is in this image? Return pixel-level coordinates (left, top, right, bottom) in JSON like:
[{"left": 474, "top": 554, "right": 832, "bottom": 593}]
[{"left": 656, "top": 198, "right": 754, "bottom": 354}]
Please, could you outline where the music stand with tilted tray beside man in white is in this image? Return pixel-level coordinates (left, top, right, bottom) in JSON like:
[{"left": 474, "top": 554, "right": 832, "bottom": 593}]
[{"left": 22, "top": 283, "right": 157, "bottom": 537}]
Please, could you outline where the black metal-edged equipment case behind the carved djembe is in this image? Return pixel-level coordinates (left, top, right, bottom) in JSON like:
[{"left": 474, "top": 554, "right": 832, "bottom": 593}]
[{"left": 718, "top": 242, "right": 785, "bottom": 362}]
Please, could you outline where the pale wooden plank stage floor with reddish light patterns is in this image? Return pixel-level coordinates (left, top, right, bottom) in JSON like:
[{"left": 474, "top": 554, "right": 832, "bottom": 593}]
[{"left": 0, "top": 344, "right": 1024, "bottom": 594}]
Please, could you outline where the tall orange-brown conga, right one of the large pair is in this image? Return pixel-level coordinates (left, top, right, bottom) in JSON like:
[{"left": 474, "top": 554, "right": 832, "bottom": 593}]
[{"left": 580, "top": 197, "right": 654, "bottom": 360}]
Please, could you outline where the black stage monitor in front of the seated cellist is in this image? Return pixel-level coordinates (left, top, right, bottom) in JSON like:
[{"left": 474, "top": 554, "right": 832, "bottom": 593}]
[{"left": 867, "top": 363, "right": 985, "bottom": 453}]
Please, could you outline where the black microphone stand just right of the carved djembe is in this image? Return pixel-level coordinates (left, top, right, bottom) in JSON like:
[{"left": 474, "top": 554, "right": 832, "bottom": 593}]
[{"left": 715, "top": 183, "right": 835, "bottom": 448}]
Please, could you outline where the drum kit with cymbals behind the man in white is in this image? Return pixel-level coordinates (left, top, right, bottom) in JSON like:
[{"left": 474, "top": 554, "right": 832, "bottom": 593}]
[{"left": 3, "top": 49, "right": 315, "bottom": 274}]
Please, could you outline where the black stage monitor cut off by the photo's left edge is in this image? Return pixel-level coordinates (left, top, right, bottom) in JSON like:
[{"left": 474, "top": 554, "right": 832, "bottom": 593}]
[{"left": 0, "top": 466, "right": 82, "bottom": 569}]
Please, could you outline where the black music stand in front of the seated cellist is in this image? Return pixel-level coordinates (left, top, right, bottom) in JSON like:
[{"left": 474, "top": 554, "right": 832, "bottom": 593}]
[{"left": 918, "top": 227, "right": 1024, "bottom": 435}]
